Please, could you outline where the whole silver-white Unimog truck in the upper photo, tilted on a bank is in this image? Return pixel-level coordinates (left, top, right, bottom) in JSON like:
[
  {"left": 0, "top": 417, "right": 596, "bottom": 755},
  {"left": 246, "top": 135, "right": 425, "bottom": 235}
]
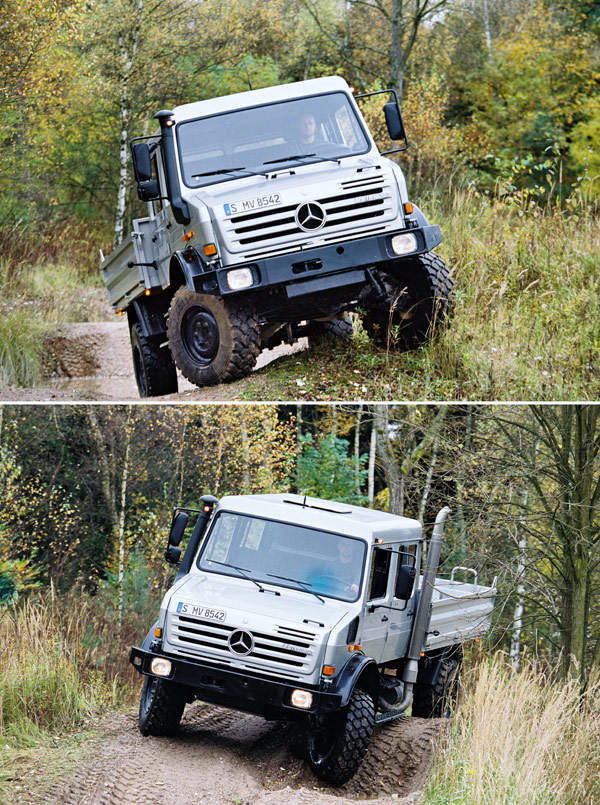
[{"left": 102, "top": 77, "right": 452, "bottom": 397}]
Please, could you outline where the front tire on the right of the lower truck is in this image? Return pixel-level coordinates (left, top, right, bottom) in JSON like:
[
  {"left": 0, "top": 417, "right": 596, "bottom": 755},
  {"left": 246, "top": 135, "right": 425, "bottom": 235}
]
[{"left": 308, "top": 690, "right": 375, "bottom": 786}]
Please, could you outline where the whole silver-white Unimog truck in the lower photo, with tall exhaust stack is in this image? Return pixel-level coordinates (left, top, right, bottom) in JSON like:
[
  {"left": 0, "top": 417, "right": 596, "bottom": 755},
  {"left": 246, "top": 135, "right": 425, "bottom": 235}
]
[{"left": 130, "top": 495, "right": 496, "bottom": 785}]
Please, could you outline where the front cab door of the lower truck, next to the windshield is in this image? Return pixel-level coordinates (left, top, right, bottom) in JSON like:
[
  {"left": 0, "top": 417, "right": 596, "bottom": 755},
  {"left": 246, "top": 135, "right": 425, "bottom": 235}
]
[{"left": 361, "top": 547, "right": 394, "bottom": 663}]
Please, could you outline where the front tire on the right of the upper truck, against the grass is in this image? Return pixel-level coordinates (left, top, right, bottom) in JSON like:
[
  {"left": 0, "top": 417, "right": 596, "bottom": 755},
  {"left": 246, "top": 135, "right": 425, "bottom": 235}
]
[{"left": 362, "top": 252, "right": 454, "bottom": 350}]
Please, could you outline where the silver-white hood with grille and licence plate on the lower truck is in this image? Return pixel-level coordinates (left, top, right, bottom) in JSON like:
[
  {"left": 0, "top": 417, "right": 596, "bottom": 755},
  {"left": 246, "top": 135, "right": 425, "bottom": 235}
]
[{"left": 164, "top": 573, "right": 351, "bottom": 679}]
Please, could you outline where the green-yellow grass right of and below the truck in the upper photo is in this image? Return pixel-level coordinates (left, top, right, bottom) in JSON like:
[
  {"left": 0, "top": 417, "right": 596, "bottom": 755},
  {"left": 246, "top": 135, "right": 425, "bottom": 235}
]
[{"left": 240, "top": 191, "right": 600, "bottom": 400}]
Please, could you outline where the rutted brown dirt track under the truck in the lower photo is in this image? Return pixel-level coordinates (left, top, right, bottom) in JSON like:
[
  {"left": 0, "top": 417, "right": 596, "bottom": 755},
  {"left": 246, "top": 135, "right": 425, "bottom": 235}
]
[{"left": 37, "top": 702, "right": 445, "bottom": 805}]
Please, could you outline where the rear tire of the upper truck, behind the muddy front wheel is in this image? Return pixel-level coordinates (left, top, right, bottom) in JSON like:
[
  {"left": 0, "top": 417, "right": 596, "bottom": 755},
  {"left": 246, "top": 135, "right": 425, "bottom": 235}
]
[{"left": 129, "top": 322, "right": 177, "bottom": 397}]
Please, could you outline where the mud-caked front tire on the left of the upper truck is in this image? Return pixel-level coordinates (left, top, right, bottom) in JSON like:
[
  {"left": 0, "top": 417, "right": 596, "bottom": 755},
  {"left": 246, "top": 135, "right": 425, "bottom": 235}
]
[{"left": 167, "top": 286, "right": 260, "bottom": 386}]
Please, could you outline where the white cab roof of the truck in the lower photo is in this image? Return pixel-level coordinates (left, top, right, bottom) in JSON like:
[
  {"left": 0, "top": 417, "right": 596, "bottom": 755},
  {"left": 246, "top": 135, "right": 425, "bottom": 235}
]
[{"left": 217, "top": 494, "right": 422, "bottom": 542}]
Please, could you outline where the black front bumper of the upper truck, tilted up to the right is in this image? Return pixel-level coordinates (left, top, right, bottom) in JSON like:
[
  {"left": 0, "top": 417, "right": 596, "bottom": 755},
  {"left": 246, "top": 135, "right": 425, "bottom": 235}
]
[{"left": 194, "top": 226, "right": 442, "bottom": 304}]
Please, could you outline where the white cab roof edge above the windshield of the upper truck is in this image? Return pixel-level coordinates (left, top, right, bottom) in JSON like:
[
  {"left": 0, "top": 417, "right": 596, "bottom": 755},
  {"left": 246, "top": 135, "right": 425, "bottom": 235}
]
[{"left": 173, "top": 75, "right": 350, "bottom": 123}]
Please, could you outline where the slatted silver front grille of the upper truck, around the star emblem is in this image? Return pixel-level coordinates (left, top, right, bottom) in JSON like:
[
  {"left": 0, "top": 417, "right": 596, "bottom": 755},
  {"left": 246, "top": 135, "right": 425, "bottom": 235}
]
[{"left": 223, "top": 176, "right": 397, "bottom": 251}]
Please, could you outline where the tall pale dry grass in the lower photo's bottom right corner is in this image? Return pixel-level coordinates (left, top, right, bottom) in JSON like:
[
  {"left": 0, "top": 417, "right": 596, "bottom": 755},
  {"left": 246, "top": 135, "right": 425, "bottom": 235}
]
[{"left": 424, "top": 656, "right": 600, "bottom": 805}]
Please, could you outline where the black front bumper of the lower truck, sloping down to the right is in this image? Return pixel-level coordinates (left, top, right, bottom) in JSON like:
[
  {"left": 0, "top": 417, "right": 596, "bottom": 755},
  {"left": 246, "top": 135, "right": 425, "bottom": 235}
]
[{"left": 129, "top": 648, "right": 342, "bottom": 719}]
